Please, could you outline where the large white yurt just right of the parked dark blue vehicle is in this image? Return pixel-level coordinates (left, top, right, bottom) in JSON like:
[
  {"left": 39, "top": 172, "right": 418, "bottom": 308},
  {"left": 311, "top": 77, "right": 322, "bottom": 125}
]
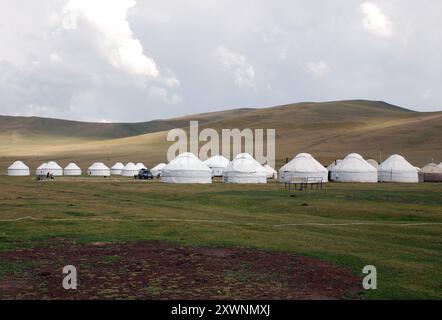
[{"left": 161, "top": 152, "right": 212, "bottom": 183}]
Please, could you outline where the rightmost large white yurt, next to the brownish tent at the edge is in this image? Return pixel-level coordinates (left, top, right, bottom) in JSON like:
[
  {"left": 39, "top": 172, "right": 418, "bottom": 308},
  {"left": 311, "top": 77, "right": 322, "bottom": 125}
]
[{"left": 378, "top": 154, "right": 419, "bottom": 183}]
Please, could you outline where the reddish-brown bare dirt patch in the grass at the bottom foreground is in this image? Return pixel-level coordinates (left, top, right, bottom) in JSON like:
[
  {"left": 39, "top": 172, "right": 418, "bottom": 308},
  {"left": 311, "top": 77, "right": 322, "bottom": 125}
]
[{"left": 0, "top": 241, "right": 361, "bottom": 299}]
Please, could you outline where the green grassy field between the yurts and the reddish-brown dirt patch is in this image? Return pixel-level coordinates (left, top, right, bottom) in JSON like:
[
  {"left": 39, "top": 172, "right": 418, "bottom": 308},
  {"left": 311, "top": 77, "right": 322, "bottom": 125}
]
[{"left": 0, "top": 177, "right": 442, "bottom": 299}]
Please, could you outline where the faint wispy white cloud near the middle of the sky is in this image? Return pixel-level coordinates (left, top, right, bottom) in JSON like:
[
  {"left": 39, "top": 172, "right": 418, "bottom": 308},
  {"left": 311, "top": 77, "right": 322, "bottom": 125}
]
[{"left": 215, "top": 46, "right": 256, "bottom": 88}]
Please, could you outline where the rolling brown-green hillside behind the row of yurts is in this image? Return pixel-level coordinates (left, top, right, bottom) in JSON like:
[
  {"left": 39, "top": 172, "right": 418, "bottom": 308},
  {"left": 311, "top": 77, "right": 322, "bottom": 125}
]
[{"left": 0, "top": 100, "right": 442, "bottom": 171}]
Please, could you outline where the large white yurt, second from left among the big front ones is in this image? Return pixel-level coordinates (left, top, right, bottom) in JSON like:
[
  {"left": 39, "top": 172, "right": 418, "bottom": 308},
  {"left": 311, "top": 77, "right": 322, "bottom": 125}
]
[{"left": 224, "top": 153, "right": 267, "bottom": 183}]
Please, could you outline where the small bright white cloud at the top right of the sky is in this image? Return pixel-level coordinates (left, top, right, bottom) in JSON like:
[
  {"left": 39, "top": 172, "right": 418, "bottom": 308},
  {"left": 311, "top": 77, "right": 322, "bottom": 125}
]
[{"left": 361, "top": 2, "right": 393, "bottom": 37}]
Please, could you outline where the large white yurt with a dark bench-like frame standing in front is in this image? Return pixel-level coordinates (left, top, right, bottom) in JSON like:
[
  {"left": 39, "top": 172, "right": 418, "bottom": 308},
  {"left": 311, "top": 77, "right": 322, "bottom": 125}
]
[{"left": 279, "top": 153, "right": 328, "bottom": 182}]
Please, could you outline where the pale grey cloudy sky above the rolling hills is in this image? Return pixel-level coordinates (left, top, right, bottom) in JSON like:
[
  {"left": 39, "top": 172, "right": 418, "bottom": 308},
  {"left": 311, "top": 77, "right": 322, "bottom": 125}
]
[{"left": 0, "top": 0, "right": 442, "bottom": 121}]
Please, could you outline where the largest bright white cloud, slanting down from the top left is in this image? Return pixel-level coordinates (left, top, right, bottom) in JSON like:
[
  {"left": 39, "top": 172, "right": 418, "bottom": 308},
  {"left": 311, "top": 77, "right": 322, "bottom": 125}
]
[{"left": 62, "top": 0, "right": 160, "bottom": 78}]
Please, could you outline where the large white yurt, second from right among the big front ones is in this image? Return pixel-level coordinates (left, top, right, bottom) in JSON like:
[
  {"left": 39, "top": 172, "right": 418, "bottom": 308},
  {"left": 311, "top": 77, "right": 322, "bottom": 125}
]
[{"left": 331, "top": 153, "right": 378, "bottom": 183}]
